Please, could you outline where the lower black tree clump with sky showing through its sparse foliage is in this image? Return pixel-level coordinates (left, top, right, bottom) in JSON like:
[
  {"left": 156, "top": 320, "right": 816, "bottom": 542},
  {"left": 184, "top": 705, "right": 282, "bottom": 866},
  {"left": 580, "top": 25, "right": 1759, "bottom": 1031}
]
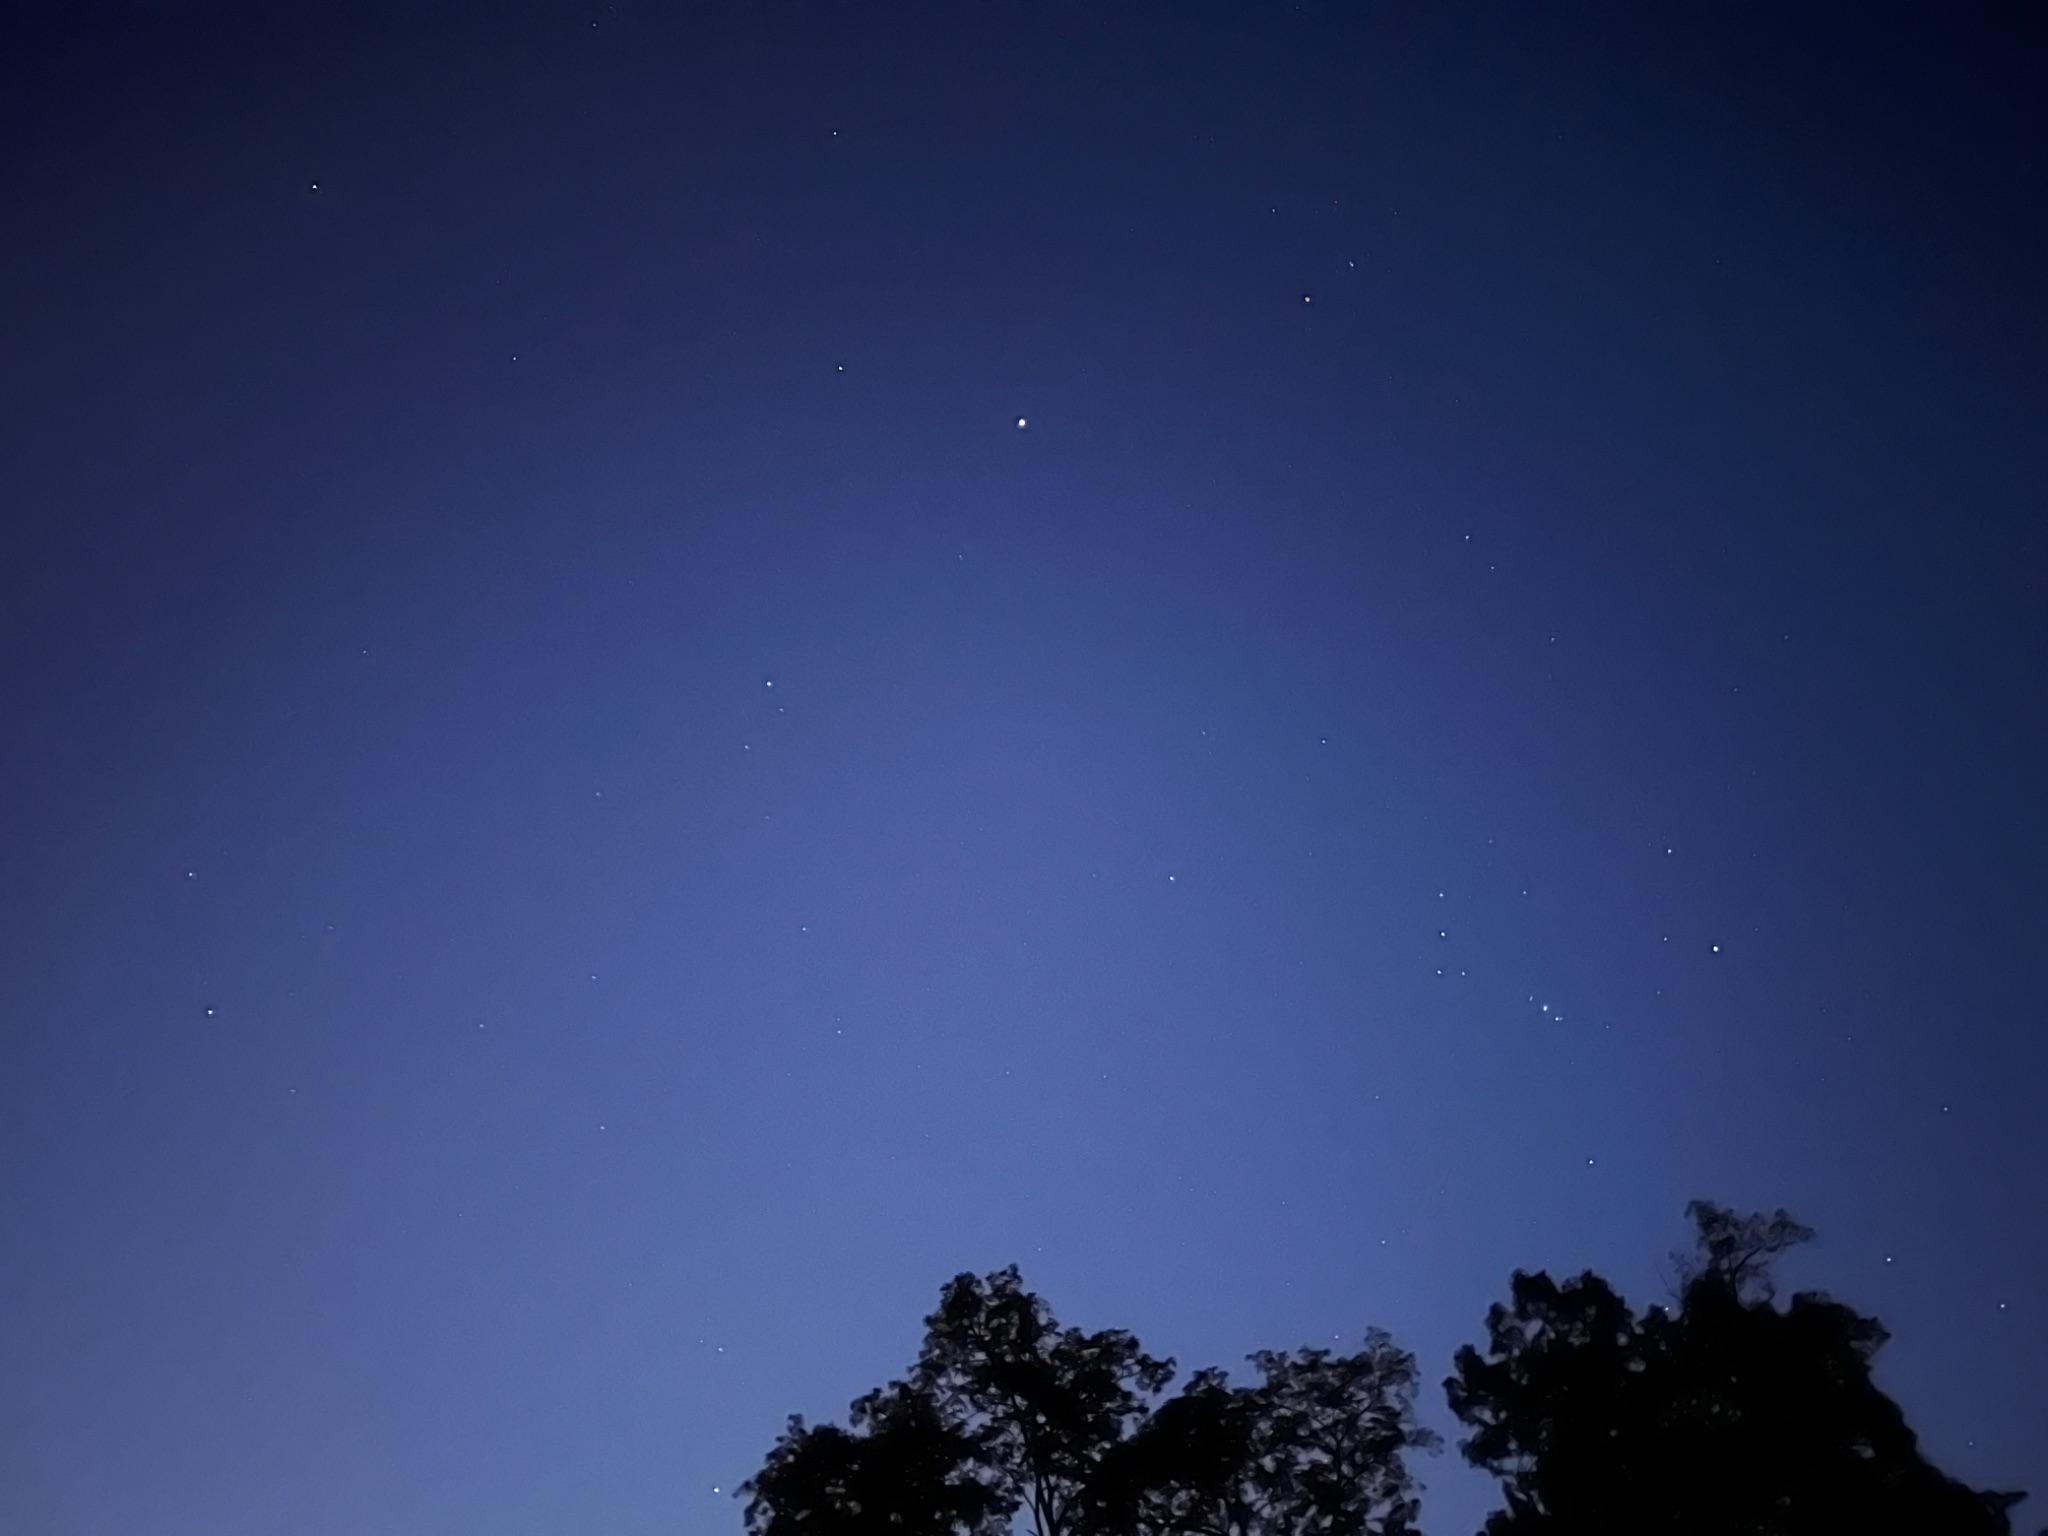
[{"left": 741, "top": 1268, "right": 1436, "bottom": 1536}]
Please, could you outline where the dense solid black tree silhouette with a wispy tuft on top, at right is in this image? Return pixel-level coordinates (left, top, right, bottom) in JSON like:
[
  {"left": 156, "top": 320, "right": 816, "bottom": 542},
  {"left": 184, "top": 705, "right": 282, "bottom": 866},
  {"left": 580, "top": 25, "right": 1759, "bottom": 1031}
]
[{"left": 1446, "top": 1200, "right": 2021, "bottom": 1536}]
